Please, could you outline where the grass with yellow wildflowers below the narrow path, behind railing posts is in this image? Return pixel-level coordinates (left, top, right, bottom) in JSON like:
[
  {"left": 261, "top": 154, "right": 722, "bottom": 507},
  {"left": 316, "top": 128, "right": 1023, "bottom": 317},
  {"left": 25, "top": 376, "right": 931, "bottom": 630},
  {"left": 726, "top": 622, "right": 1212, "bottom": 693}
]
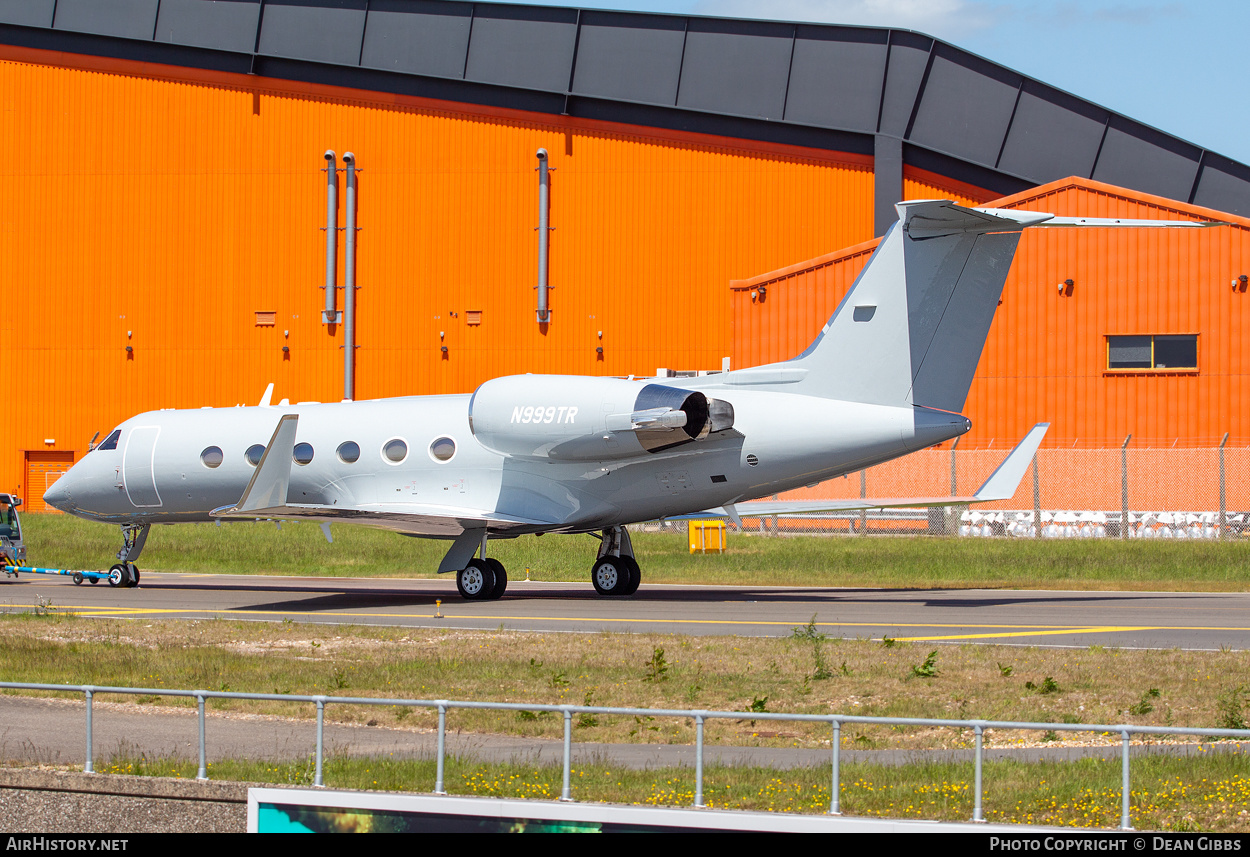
[{"left": 96, "top": 753, "right": 1250, "bottom": 832}]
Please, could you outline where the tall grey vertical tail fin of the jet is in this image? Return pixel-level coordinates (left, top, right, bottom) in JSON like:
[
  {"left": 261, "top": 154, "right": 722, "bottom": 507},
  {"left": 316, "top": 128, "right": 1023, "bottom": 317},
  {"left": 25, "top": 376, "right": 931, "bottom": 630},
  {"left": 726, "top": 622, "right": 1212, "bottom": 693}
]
[{"left": 790, "top": 200, "right": 1051, "bottom": 412}]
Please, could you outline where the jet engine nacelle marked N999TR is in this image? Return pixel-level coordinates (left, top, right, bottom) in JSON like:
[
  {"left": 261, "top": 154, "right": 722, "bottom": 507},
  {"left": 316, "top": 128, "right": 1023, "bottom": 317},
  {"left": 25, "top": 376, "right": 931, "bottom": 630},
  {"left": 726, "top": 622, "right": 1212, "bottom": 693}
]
[{"left": 469, "top": 375, "right": 734, "bottom": 461}]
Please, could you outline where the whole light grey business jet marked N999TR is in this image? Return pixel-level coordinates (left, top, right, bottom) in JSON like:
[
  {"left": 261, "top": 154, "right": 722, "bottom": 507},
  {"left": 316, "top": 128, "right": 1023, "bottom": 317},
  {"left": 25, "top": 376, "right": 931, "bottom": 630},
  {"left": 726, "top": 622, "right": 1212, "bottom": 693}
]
[{"left": 44, "top": 201, "right": 1199, "bottom": 598}]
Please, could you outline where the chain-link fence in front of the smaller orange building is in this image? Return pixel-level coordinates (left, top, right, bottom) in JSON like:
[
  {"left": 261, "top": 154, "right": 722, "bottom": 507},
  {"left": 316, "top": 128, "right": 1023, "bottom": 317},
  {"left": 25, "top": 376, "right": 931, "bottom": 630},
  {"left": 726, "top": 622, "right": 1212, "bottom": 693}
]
[{"left": 675, "top": 437, "right": 1250, "bottom": 538}]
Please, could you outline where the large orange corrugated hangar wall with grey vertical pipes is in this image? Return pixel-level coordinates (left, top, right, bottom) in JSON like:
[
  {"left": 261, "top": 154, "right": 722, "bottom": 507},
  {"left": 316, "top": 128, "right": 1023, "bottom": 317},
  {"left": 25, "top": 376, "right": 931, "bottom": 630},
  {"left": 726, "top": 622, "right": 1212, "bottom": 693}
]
[{"left": 0, "top": 47, "right": 873, "bottom": 508}]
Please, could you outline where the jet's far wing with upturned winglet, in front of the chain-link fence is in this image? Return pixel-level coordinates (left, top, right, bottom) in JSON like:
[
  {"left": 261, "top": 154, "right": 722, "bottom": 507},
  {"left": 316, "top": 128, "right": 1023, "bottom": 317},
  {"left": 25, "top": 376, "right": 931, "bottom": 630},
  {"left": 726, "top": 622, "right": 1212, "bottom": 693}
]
[{"left": 665, "top": 422, "right": 1050, "bottom": 523}]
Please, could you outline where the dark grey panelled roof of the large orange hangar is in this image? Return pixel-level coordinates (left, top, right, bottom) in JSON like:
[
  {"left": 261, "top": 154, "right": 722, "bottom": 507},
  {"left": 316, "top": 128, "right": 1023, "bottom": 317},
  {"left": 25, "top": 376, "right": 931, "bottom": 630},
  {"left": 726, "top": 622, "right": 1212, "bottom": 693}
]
[{"left": 9, "top": 0, "right": 1250, "bottom": 224}]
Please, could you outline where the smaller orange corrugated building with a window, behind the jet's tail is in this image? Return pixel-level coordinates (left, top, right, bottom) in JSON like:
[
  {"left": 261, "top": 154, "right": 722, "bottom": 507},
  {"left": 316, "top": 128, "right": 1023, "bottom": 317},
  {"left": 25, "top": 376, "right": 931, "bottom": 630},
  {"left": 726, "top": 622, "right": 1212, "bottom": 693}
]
[{"left": 731, "top": 179, "right": 1250, "bottom": 448}]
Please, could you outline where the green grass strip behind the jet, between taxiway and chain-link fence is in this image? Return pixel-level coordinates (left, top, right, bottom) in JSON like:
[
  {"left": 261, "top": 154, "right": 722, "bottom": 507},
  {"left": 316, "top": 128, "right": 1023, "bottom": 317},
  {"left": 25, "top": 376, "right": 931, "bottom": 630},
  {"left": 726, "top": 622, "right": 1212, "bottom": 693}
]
[{"left": 23, "top": 515, "right": 1250, "bottom": 591}]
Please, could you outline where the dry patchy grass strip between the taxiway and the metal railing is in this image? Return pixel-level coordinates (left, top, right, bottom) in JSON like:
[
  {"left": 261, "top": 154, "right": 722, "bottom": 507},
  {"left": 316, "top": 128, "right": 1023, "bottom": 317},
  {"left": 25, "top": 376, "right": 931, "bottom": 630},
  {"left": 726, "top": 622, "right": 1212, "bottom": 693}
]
[{"left": 0, "top": 614, "right": 1250, "bottom": 750}]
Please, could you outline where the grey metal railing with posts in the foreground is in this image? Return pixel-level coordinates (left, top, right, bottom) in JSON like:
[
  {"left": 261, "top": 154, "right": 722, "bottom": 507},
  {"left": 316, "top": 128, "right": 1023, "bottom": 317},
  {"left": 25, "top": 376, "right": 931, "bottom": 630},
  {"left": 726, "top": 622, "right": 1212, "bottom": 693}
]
[{"left": 0, "top": 682, "right": 1250, "bottom": 831}]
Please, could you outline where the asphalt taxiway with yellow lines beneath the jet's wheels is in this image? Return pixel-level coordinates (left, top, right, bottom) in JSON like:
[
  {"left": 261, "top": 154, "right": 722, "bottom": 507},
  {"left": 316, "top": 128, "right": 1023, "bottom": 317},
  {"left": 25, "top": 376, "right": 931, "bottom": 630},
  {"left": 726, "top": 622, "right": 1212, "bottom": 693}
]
[{"left": 0, "top": 572, "right": 1250, "bottom": 650}]
